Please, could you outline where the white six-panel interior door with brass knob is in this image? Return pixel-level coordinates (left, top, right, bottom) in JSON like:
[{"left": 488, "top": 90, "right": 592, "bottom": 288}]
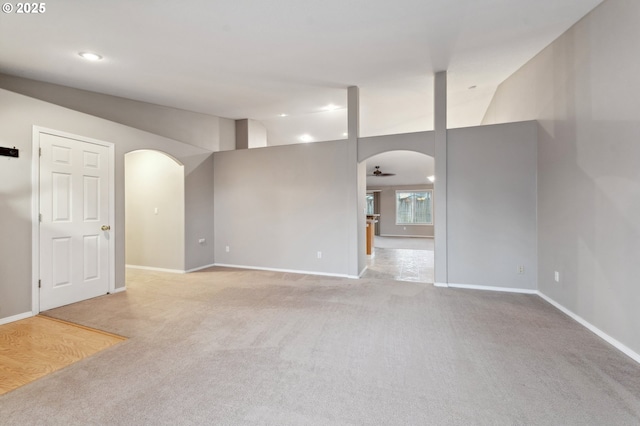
[{"left": 40, "top": 133, "right": 111, "bottom": 311}]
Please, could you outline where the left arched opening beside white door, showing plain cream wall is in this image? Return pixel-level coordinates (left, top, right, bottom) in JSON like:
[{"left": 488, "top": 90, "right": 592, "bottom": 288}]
[{"left": 125, "top": 150, "right": 185, "bottom": 272}]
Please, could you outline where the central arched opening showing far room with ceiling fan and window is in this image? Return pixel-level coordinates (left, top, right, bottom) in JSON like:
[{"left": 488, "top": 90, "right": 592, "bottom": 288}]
[{"left": 364, "top": 150, "right": 435, "bottom": 283}]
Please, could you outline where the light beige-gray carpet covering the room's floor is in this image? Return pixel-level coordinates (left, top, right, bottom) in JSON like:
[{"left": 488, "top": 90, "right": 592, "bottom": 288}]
[{"left": 0, "top": 269, "right": 640, "bottom": 425}]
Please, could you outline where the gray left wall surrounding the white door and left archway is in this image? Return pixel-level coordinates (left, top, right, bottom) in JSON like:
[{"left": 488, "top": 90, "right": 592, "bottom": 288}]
[{"left": 0, "top": 89, "right": 213, "bottom": 319}]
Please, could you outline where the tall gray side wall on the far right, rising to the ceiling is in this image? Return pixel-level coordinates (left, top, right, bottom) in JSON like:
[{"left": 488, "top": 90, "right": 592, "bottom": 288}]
[{"left": 485, "top": 0, "right": 640, "bottom": 353}]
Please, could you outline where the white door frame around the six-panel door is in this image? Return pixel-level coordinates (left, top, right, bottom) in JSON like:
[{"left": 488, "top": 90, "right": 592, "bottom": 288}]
[{"left": 31, "top": 126, "right": 116, "bottom": 315}]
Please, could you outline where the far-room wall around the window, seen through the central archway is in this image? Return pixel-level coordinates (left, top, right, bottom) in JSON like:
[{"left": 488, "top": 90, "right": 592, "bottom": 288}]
[{"left": 367, "top": 184, "right": 433, "bottom": 237}]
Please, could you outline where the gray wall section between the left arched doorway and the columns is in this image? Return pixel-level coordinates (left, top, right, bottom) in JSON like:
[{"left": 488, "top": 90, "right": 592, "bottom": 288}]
[{"left": 214, "top": 141, "right": 352, "bottom": 275}]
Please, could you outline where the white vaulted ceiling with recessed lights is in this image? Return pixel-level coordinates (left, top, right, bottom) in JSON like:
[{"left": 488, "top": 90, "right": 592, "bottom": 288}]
[{"left": 0, "top": 0, "right": 602, "bottom": 145}]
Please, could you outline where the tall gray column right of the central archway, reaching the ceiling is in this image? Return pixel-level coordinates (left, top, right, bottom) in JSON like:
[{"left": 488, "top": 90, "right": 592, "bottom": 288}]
[{"left": 433, "top": 71, "right": 449, "bottom": 287}]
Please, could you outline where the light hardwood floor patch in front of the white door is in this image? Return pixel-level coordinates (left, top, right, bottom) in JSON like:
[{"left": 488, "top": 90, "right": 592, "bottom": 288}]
[{"left": 0, "top": 315, "right": 126, "bottom": 395}]
